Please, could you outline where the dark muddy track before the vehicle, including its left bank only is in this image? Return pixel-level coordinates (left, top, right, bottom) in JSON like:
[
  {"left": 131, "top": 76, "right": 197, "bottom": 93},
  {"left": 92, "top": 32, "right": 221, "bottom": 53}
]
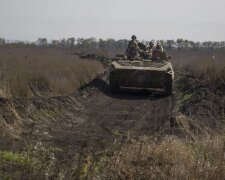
[{"left": 0, "top": 73, "right": 175, "bottom": 165}]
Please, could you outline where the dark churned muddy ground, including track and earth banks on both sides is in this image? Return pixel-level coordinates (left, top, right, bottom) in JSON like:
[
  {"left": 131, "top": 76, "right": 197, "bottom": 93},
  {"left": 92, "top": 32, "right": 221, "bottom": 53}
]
[{"left": 0, "top": 70, "right": 225, "bottom": 177}]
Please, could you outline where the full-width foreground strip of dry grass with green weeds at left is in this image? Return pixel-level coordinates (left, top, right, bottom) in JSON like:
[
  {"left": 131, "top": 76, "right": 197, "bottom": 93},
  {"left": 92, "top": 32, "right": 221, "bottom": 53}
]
[{"left": 0, "top": 130, "right": 225, "bottom": 180}]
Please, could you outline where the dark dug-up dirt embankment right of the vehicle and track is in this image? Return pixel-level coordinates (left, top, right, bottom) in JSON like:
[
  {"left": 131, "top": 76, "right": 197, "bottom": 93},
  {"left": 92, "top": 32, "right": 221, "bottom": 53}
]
[{"left": 176, "top": 72, "right": 225, "bottom": 130}]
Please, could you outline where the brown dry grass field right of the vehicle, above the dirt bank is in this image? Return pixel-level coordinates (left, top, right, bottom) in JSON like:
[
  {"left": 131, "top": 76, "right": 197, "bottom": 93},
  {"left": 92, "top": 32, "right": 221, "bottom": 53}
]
[{"left": 171, "top": 50, "right": 225, "bottom": 88}]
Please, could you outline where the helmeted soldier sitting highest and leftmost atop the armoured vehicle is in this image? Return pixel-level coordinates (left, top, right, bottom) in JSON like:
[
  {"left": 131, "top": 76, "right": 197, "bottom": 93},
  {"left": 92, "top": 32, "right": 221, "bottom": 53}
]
[{"left": 126, "top": 35, "right": 140, "bottom": 60}]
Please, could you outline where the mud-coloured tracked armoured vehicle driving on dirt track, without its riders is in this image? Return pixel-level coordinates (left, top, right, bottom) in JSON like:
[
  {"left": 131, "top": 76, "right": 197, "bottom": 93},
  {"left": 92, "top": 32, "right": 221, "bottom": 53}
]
[{"left": 109, "top": 57, "right": 174, "bottom": 96}]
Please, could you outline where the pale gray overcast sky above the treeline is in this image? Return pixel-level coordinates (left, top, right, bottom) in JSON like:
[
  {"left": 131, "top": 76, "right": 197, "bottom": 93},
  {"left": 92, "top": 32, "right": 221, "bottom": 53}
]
[{"left": 0, "top": 0, "right": 225, "bottom": 41}]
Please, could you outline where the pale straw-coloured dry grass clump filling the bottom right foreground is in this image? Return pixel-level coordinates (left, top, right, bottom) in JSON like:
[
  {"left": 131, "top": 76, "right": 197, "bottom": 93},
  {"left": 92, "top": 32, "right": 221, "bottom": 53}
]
[{"left": 100, "top": 136, "right": 225, "bottom": 179}]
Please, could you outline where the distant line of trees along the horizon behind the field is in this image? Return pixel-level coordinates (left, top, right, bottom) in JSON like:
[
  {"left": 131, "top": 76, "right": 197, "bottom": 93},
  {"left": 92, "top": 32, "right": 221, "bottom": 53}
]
[{"left": 0, "top": 37, "right": 225, "bottom": 51}]
